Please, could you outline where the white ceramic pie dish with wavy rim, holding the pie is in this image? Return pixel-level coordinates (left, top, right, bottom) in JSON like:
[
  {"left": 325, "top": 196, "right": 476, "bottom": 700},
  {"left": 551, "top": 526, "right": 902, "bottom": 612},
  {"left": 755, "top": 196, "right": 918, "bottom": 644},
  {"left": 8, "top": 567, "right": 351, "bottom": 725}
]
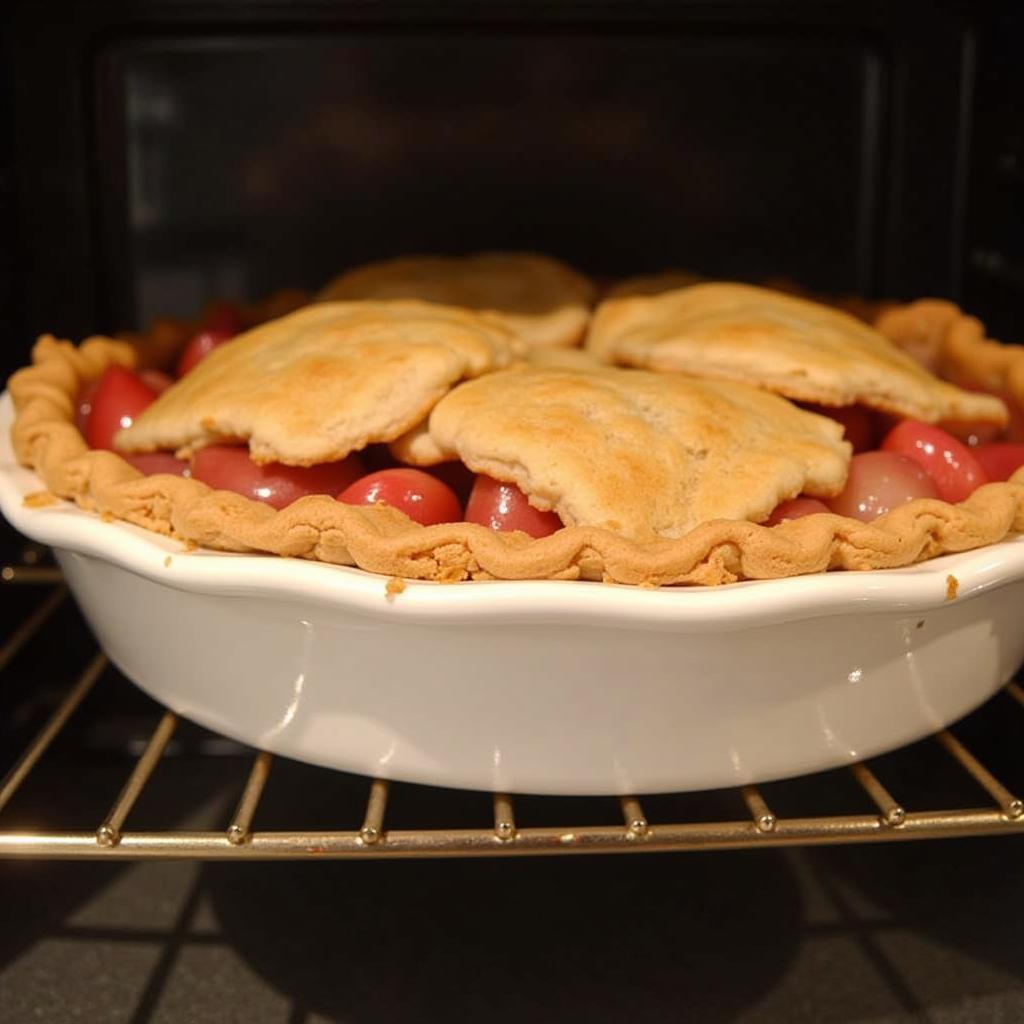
[{"left": 0, "top": 387, "right": 1024, "bottom": 794}]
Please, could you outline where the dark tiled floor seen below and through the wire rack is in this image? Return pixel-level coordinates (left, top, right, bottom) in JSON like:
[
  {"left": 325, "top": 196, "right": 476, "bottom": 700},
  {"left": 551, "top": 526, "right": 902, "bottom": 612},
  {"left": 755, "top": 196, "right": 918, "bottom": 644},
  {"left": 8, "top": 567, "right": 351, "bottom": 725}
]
[{"left": 0, "top": 581, "right": 1024, "bottom": 1024}]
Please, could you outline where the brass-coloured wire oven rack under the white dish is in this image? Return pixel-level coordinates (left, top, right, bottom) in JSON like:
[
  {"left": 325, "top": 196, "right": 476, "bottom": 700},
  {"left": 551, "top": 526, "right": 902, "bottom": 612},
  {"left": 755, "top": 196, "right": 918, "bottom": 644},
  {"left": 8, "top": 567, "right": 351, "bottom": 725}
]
[{"left": 0, "top": 564, "right": 1024, "bottom": 860}]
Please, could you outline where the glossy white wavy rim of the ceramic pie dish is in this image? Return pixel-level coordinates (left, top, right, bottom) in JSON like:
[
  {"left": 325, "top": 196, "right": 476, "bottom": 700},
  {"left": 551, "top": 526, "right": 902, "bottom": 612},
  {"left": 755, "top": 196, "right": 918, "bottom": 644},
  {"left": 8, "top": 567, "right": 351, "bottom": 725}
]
[{"left": 0, "top": 442, "right": 1024, "bottom": 636}]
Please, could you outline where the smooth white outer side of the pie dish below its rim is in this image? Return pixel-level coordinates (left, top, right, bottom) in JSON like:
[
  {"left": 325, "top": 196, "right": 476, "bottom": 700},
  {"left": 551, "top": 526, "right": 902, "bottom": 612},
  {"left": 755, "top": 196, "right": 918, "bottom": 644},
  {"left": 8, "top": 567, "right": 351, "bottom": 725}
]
[{"left": 44, "top": 550, "right": 1024, "bottom": 794}]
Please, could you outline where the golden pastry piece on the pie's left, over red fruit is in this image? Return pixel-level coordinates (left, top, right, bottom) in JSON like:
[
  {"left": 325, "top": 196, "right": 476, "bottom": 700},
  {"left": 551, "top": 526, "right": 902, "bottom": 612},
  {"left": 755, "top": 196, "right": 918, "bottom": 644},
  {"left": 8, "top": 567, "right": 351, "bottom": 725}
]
[{"left": 117, "top": 301, "right": 512, "bottom": 466}]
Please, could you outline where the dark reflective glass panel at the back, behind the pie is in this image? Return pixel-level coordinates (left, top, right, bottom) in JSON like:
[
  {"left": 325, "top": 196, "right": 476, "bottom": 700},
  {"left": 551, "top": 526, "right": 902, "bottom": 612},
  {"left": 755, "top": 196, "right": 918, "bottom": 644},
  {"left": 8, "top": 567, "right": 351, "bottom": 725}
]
[{"left": 100, "top": 27, "right": 883, "bottom": 323}]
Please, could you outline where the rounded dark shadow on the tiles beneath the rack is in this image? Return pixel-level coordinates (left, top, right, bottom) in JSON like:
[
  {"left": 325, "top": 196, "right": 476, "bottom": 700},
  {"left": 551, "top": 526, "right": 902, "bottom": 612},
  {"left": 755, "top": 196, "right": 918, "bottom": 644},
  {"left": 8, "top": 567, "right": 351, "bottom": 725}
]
[{"left": 204, "top": 853, "right": 801, "bottom": 1024}]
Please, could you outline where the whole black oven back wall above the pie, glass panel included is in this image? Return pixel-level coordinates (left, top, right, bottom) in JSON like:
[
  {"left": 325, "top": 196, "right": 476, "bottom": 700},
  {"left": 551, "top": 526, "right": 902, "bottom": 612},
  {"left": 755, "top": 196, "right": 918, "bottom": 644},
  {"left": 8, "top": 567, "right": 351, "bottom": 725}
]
[{"left": 2, "top": 0, "right": 1014, "bottom": 380}]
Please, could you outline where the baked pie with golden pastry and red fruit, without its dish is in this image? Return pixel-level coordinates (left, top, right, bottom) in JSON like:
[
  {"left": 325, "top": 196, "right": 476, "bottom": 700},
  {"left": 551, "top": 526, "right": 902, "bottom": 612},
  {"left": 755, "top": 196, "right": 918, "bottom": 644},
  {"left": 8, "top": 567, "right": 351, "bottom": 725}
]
[{"left": 10, "top": 272, "right": 1024, "bottom": 586}]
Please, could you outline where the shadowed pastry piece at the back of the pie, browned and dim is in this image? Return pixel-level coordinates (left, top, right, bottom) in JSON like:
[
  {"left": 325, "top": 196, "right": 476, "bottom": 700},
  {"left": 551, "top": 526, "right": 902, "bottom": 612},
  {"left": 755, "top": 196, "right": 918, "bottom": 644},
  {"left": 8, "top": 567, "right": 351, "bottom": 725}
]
[{"left": 317, "top": 252, "right": 594, "bottom": 347}]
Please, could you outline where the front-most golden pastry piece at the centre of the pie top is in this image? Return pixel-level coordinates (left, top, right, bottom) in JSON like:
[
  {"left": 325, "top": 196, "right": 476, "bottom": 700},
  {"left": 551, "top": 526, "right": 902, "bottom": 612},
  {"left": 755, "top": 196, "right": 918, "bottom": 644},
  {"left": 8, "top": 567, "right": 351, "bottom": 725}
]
[{"left": 413, "top": 366, "right": 850, "bottom": 541}]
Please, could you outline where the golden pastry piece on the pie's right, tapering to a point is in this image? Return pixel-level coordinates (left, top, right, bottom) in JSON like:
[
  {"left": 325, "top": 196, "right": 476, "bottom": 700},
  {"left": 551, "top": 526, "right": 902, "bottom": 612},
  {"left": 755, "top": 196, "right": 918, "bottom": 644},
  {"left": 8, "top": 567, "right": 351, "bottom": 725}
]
[{"left": 587, "top": 283, "right": 1007, "bottom": 424}]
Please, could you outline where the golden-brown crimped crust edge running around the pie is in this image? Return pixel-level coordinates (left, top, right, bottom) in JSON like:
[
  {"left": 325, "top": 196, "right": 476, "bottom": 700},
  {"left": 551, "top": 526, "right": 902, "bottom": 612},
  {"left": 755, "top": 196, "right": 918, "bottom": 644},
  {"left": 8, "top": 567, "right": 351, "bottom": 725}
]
[{"left": 9, "top": 304, "right": 1024, "bottom": 587}]
